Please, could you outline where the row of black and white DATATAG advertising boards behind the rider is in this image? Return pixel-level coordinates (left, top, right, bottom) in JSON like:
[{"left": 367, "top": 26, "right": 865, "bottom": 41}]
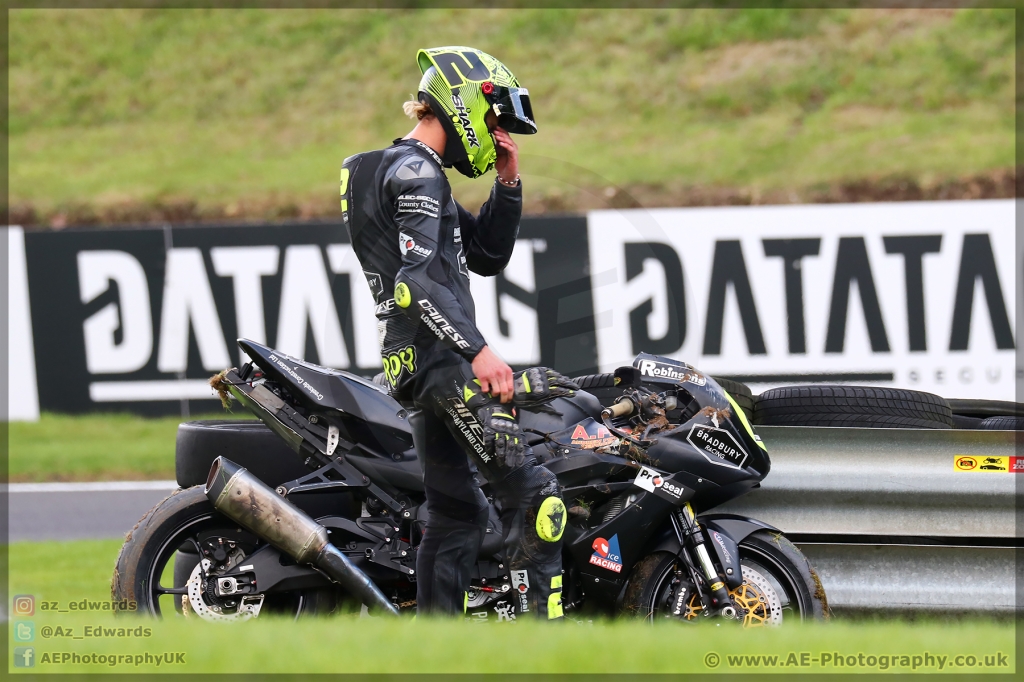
[{"left": 8, "top": 201, "right": 1021, "bottom": 418}]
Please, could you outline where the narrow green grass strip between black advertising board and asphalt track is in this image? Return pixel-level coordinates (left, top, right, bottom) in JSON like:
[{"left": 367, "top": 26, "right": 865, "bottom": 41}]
[{"left": 8, "top": 410, "right": 251, "bottom": 481}]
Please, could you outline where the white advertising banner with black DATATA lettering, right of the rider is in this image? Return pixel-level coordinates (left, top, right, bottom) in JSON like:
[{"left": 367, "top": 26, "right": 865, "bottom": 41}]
[{"left": 588, "top": 200, "right": 1021, "bottom": 400}]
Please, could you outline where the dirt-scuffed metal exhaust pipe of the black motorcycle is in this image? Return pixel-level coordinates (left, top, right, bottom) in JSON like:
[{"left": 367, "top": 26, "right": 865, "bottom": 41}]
[{"left": 204, "top": 457, "right": 398, "bottom": 615}]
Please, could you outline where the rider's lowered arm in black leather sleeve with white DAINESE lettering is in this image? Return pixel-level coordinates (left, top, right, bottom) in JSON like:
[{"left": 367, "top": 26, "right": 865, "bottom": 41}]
[{"left": 386, "top": 159, "right": 486, "bottom": 361}]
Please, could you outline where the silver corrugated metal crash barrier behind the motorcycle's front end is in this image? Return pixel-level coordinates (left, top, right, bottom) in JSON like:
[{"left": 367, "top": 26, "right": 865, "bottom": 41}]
[{"left": 721, "top": 426, "right": 1018, "bottom": 612}]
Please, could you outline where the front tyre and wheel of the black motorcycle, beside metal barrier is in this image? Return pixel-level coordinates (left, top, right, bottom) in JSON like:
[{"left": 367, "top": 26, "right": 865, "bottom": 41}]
[{"left": 623, "top": 530, "right": 828, "bottom": 624}]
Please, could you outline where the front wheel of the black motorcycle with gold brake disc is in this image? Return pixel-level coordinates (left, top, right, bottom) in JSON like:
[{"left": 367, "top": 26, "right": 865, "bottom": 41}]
[{"left": 623, "top": 530, "right": 828, "bottom": 627}]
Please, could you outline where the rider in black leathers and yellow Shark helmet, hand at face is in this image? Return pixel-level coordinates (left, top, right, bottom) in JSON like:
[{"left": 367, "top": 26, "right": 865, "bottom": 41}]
[{"left": 341, "top": 47, "right": 575, "bottom": 619}]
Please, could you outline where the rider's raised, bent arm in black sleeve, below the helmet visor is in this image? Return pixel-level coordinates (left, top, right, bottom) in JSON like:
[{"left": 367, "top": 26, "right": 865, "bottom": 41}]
[{"left": 459, "top": 181, "right": 522, "bottom": 276}]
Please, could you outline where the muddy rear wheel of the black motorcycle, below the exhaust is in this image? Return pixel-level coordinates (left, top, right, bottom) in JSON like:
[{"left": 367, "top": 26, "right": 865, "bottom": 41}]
[{"left": 111, "top": 485, "right": 347, "bottom": 617}]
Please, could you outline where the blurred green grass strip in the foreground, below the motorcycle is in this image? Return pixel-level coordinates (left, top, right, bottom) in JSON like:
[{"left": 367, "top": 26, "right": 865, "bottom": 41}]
[{"left": 9, "top": 541, "right": 1015, "bottom": 674}]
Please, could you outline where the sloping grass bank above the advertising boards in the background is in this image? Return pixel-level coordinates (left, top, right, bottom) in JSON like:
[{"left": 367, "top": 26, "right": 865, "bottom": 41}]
[{"left": 9, "top": 9, "right": 1014, "bottom": 220}]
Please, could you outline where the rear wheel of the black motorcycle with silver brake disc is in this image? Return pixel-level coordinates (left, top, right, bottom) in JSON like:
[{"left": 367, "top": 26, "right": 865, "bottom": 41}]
[{"left": 111, "top": 485, "right": 348, "bottom": 621}]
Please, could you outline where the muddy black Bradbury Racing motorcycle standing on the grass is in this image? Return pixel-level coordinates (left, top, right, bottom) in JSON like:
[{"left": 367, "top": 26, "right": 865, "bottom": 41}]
[{"left": 112, "top": 339, "right": 827, "bottom": 626}]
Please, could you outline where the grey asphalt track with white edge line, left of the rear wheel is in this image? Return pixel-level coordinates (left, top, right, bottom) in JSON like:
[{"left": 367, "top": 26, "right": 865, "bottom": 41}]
[{"left": 7, "top": 480, "right": 178, "bottom": 543}]
